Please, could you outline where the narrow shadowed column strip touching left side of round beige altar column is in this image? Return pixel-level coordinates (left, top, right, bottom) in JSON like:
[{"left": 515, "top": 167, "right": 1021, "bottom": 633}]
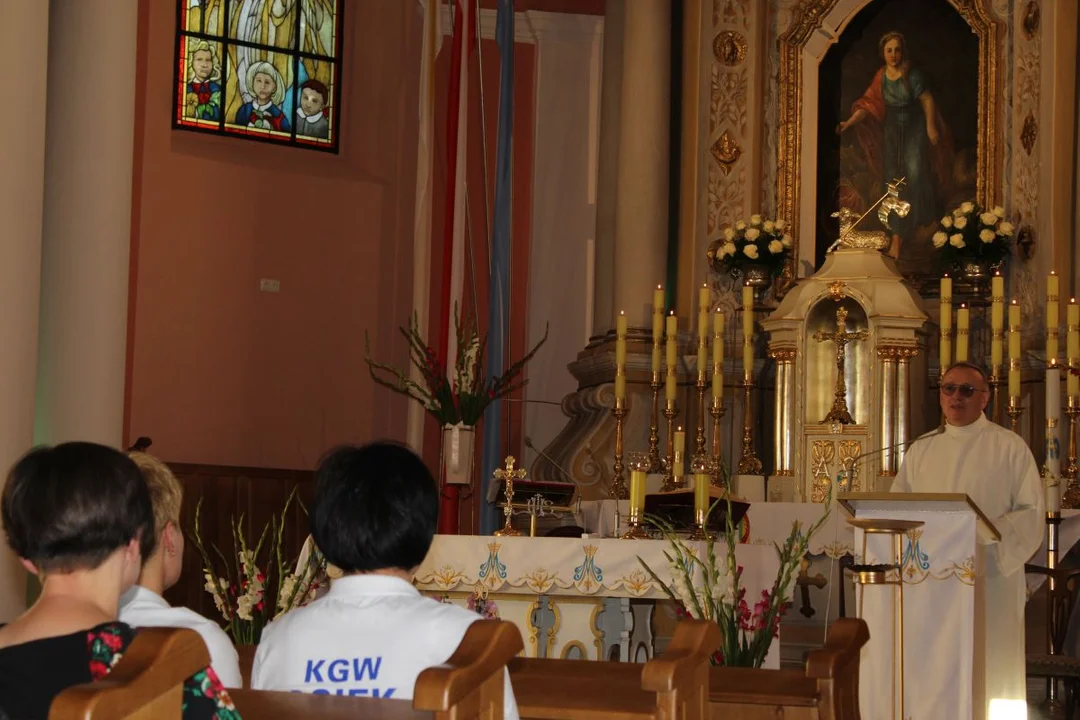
[{"left": 593, "top": 0, "right": 626, "bottom": 336}]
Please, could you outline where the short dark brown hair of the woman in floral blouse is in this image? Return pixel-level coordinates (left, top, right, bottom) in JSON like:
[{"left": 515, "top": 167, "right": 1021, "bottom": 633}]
[{"left": 0, "top": 443, "right": 156, "bottom": 572}]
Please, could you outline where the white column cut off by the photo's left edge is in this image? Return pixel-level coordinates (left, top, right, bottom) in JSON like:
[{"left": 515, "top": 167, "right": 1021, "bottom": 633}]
[{"left": 0, "top": 0, "right": 49, "bottom": 622}]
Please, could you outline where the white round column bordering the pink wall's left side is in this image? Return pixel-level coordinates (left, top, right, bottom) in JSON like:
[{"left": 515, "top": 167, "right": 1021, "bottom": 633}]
[{"left": 35, "top": 0, "right": 138, "bottom": 446}]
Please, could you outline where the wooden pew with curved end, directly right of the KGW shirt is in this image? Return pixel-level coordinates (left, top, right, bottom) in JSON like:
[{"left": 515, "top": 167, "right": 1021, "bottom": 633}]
[{"left": 510, "top": 620, "right": 720, "bottom": 720}]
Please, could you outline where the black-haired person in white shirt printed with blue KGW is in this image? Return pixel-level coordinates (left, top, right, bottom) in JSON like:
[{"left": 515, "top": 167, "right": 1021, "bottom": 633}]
[{"left": 252, "top": 443, "right": 518, "bottom": 720}]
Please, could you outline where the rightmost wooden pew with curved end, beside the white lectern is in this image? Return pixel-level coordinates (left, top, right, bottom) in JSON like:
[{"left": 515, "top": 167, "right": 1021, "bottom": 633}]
[{"left": 708, "top": 617, "right": 869, "bottom": 720}]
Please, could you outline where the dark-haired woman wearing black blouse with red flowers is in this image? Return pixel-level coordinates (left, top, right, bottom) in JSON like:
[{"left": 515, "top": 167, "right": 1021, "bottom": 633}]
[{"left": 0, "top": 443, "right": 240, "bottom": 719}]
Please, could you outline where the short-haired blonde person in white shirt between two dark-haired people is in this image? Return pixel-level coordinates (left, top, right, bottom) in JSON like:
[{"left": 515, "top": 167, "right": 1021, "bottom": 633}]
[{"left": 120, "top": 452, "right": 244, "bottom": 688}]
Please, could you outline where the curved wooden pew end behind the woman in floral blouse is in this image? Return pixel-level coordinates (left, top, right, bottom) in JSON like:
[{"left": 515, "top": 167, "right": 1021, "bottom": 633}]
[{"left": 49, "top": 627, "right": 210, "bottom": 720}]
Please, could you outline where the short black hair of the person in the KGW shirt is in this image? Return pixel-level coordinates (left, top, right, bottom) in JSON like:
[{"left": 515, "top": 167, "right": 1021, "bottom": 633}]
[{"left": 311, "top": 441, "right": 438, "bottom": 572}]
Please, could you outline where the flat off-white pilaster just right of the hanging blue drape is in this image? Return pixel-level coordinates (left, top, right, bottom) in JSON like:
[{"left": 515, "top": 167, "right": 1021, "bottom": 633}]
[{"left": 524, "top": 11, "right": 611, "bottom": 472}]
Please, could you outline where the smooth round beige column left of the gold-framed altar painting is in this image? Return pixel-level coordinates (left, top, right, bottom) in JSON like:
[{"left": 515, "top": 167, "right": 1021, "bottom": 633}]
[{"left": 612, "top": 0, "right": 671, "bottom": 327}]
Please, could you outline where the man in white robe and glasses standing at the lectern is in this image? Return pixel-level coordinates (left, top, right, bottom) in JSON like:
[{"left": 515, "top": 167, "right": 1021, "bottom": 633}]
[{"left": 892, "top": 363, "right": 1045, "bottom": 702}]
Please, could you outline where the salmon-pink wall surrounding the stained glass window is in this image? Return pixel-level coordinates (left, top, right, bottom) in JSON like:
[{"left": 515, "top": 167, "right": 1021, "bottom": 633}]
[{"left": 125, "top": 0, "right": 422, "bottom": 468}]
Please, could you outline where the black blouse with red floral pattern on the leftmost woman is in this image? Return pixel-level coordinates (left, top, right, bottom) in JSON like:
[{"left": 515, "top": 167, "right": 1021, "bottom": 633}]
[{"left": 0, "top": 622, "right": 240, "bottom": 720}]
